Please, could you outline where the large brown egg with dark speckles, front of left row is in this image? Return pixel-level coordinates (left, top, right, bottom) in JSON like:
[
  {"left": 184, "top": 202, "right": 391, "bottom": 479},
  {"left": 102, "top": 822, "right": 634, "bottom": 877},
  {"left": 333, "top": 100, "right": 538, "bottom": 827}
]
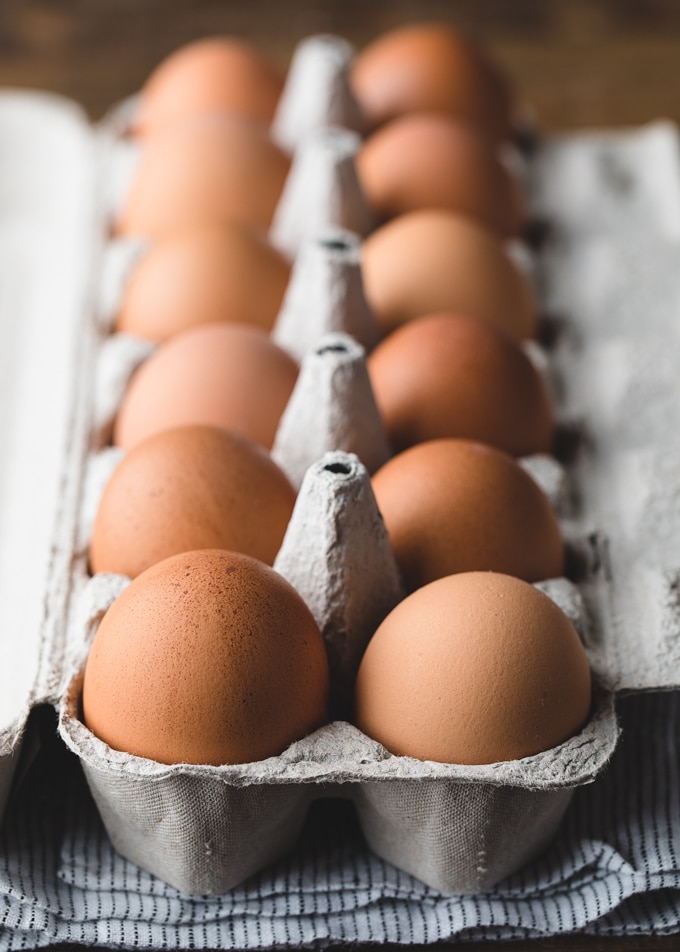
[{"left": 83, "top": 549, "right": 328, "bottom": 765}]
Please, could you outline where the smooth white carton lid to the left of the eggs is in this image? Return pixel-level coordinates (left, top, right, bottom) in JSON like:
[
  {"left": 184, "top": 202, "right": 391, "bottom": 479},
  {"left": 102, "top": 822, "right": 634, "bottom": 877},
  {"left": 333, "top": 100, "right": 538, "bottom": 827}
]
[{"left": 0, "top": 91, "right": 98, "bottom": 750}]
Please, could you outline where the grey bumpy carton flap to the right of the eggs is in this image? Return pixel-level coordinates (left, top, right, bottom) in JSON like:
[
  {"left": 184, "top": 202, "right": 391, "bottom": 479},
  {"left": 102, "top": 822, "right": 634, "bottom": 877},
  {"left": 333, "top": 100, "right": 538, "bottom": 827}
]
[{"left": 527, "top": 121, "right": 680, "bottom": 692}]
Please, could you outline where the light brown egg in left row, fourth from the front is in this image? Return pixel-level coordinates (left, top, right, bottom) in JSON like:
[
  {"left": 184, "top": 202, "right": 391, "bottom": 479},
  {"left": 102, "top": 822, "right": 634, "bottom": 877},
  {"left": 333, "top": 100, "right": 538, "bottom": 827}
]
[{"left": 116, "top": 222, "right": 290, "bottom": 341}]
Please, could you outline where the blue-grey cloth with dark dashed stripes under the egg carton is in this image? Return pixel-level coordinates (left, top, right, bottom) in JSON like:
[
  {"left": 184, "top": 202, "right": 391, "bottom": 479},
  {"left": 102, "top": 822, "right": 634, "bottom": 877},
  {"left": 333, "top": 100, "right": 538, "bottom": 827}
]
[{"left": 0, "top": 693, "right": 680, "bottom": 950}]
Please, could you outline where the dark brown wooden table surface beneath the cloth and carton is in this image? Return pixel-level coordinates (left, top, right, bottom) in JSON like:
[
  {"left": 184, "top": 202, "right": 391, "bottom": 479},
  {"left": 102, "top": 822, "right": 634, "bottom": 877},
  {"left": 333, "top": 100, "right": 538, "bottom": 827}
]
[{"left": 0, "top": 0, "right": 680, "bottom": 952}]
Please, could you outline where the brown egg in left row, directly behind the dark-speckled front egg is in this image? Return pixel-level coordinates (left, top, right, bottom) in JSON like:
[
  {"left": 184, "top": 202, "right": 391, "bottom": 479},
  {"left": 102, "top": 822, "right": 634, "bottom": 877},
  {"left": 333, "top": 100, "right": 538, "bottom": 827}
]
[{"left": 90, "top": 426, "right": 296, "bottom": 578}]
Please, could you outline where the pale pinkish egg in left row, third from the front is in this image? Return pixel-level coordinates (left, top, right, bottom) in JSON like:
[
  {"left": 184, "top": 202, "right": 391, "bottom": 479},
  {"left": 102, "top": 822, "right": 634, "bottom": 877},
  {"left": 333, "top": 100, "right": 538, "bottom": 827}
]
[{"left": 113, "top": 324, "right": 298, "bottom": 450}]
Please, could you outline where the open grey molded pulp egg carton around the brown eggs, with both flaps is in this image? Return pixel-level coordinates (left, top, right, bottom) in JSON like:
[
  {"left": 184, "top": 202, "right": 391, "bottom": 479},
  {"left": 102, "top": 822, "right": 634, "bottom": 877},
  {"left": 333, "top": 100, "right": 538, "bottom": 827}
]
[{"left": 0, "top": 38, "right": 680, "bottom": 894}]
